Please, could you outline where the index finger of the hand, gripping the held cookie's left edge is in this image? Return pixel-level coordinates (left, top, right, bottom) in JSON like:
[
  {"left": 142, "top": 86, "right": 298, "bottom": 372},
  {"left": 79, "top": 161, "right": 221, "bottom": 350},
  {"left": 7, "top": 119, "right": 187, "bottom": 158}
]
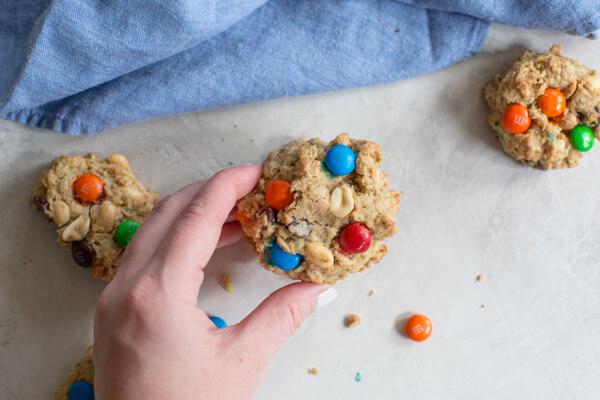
[{"left": 156, "top": 165, "right": 261, "bottom": 303}]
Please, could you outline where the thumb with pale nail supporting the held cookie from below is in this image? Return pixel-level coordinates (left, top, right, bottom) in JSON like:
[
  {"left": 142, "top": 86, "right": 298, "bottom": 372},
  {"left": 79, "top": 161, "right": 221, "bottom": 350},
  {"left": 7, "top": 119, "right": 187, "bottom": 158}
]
[{"left": 237, "top": 282, "right": 337, "bottom": 362}]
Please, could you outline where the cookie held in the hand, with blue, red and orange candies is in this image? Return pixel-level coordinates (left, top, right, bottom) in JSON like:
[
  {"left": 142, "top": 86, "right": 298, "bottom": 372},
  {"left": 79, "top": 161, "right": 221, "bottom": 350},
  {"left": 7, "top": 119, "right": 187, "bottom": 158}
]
[{"left": 236, "top": 134, "right": 400, "bottom": 284}]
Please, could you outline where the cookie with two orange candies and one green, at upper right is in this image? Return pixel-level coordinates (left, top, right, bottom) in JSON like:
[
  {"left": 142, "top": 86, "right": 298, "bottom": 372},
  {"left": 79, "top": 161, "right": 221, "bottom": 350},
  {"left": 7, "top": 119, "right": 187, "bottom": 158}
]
[{"left": 483, "top": 46, "right": 600, "bottom": 170}]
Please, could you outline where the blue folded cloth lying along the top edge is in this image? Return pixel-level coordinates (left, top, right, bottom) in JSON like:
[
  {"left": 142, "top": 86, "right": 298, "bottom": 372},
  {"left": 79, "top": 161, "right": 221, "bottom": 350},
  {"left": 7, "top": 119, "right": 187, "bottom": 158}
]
[{"left": 0, "top": 0, "right": 600, "bottom": 134}]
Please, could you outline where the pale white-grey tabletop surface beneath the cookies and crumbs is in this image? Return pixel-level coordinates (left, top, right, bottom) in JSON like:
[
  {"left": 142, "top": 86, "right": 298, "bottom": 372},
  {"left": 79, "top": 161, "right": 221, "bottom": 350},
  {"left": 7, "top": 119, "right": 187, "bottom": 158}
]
[{"left": 0, "top": 26, "right": 600, "bottom": 400}]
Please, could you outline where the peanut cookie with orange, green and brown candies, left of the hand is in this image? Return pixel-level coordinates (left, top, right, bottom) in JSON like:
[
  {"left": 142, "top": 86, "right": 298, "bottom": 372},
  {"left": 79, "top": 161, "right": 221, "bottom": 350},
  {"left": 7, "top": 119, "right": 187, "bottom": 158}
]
[{"left": 30, "top": 154, "right": 158, "bottom": 281}]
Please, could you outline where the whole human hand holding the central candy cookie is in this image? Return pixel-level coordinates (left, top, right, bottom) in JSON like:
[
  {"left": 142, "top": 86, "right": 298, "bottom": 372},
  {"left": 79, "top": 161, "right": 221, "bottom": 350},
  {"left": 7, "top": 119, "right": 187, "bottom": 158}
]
[{"left": 94, "top": 165, "right": 335, "bottom": 400}]
